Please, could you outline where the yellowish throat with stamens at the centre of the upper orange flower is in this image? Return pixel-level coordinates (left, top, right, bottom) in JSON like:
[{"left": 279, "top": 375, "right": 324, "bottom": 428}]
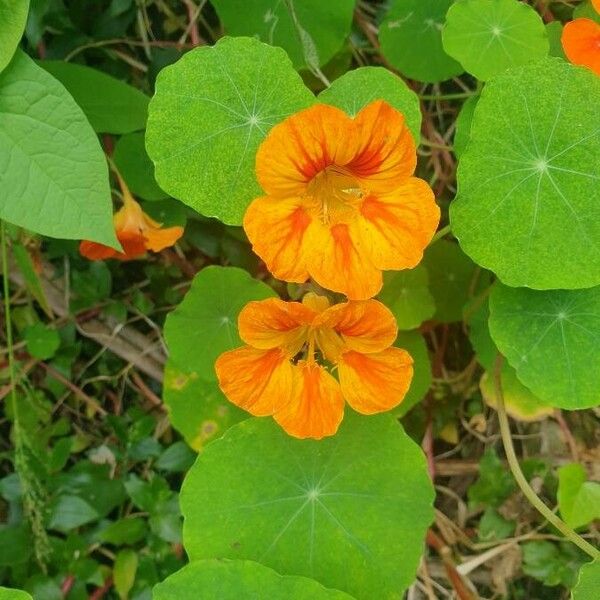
[{"left": 307, "top": 165, "right": 364, "bottom": 225}]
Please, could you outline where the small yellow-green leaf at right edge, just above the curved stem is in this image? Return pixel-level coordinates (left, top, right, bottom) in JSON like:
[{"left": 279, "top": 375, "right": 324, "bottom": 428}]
[{"left": 557, "top": 463, "right": 600, "bottom": 529}]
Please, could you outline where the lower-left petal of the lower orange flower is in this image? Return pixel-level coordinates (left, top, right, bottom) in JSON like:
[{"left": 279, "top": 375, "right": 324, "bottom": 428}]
[{"left": 215, "top": 346, "right": 293, "bottom": 417}]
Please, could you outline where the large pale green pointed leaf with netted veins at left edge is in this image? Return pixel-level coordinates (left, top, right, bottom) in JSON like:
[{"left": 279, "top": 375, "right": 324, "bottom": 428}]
[{"left": 0, "top": 51, "right": 118, "bottom": 247}]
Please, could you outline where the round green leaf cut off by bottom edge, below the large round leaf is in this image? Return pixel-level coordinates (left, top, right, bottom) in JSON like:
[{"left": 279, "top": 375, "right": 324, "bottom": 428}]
[{"left": 152, "top": 560, "right": 351, "bottom": 600}]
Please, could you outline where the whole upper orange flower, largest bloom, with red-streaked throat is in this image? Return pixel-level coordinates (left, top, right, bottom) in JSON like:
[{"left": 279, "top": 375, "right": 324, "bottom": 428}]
[{"left": 244, "top": 100, "right": 440, "bottom": 300}]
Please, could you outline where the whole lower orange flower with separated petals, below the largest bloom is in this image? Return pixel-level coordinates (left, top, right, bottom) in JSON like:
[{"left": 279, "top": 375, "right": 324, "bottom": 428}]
[{"left": 215, "top": 294, "right": 413, "bottom": 439}]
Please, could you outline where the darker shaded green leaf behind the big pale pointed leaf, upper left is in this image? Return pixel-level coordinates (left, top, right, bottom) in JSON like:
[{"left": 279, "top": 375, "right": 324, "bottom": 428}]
[{"left": 39, "top": 60, "right": 150, "bottom": 133}]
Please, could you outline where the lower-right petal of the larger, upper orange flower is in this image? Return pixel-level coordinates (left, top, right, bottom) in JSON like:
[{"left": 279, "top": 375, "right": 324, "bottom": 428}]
[{"left": 349, "top": 177, "right": 440, "bottom": 270}]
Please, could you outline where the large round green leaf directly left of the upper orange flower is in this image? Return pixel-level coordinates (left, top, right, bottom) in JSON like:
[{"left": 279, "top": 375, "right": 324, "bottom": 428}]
[{"left": 146, "top": 38, "right": 313, "bottom": 225}]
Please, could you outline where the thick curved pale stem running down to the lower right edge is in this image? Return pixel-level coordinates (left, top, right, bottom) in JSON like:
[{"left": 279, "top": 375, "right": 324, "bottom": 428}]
[{"left": 494, "top": 355, "right": 600, "bottom": 560}]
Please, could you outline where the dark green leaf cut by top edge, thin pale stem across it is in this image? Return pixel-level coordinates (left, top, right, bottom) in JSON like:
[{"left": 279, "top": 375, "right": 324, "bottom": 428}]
[{"left": 212, "top": 0, "right": 356, "bottom": 67}]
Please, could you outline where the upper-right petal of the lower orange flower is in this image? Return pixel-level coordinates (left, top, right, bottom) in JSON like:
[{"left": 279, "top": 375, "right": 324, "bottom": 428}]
[{"left": 314, "top": 300, "right": 398, "bottom": 354}]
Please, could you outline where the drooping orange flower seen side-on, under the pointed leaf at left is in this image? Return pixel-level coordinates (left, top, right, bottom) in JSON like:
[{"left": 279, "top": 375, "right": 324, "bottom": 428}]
[{"left": 79, "top": 177, "right": 183, "bottom": 260}]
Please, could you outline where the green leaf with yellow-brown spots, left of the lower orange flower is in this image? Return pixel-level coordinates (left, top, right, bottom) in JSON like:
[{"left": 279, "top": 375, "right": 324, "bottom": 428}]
[{"left": 163, "top": 360, "right": 248, "bottom": 451}]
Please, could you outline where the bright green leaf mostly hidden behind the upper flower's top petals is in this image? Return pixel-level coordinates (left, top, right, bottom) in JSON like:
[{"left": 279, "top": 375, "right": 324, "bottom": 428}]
[{"left": 319, "top": 67, "right": 421, "bottom": 144}]
